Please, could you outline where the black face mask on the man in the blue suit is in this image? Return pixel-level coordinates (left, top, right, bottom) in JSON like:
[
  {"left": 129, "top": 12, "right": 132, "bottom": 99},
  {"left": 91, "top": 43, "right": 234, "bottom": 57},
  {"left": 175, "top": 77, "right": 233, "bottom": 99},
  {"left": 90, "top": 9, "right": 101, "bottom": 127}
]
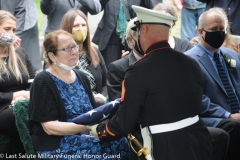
[{"left": 202, "top": 28, "right": 226, "bottom": 48}]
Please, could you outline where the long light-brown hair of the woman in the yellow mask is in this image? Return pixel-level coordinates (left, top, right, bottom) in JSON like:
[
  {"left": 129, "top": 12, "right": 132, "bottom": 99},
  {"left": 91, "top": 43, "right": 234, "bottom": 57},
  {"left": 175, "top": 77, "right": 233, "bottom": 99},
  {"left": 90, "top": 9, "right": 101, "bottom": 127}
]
[{"left": 61, "top": 9, "right": 100, "bottom": 68}]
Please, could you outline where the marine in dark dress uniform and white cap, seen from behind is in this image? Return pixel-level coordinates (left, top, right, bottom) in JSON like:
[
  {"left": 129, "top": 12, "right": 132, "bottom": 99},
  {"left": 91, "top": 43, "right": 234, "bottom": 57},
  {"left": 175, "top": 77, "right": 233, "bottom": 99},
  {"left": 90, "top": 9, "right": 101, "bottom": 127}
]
[{"left": 94, "top": 6, "right": 212, "bottom": 160}]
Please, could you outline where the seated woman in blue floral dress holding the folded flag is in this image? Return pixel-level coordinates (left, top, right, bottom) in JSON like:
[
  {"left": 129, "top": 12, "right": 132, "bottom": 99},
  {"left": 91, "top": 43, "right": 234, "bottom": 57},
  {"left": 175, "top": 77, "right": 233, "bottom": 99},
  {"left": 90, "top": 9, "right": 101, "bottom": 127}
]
[{"left": 29, "top": 30, "right": 130, "bottom": 159}]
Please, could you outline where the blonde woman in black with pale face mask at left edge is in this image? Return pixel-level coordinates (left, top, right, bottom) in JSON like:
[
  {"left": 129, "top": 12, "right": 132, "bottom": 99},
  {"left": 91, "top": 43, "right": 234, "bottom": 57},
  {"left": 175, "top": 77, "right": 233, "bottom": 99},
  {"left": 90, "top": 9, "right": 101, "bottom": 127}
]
[{"left": 0, "top": 10, "right": 34, "bottom": 152}]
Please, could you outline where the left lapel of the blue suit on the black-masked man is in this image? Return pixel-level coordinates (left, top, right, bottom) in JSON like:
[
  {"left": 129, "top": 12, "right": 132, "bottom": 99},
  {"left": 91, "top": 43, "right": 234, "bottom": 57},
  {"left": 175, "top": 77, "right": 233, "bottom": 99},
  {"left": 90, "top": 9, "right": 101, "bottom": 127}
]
[{"left": 198, "top": 47, "right": 227, "bottom": 95}]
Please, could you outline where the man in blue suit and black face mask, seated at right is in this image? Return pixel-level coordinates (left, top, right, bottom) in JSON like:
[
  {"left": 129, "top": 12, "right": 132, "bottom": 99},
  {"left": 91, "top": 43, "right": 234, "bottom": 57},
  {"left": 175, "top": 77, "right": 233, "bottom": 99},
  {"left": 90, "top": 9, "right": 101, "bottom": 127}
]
[{"left": 186, "top": 10, "right": 240, "bottom": 159}]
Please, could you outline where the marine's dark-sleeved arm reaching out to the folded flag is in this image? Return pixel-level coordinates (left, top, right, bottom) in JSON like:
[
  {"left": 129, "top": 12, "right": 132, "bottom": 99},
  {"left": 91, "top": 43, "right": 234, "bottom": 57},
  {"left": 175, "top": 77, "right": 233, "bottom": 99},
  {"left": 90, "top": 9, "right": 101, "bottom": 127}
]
[{"left": 97, "top": 68, "right": 143, "bottom": 141}]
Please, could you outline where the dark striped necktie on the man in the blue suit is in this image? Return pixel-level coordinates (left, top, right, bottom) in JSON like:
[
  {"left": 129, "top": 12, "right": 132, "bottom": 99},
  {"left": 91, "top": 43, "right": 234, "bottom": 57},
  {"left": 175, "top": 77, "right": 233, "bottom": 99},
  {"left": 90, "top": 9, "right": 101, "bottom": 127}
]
[{"left": 214, "top": 53, "right": 239, "bottom": 113}]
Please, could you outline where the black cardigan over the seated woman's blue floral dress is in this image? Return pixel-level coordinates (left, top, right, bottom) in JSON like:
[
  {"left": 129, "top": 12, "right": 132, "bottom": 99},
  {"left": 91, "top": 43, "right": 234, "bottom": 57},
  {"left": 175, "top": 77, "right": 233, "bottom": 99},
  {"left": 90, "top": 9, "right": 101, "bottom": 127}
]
[{"left": 29, "top": 69, "right": 96, "bottom": 150}]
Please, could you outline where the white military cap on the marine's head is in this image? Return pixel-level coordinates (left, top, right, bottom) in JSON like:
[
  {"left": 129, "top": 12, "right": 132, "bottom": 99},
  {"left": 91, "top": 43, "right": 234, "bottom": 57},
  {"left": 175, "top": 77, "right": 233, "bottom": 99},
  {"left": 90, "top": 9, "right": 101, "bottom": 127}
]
[{"left": 132, "top": 5, "right": 177, "bottom": 27}]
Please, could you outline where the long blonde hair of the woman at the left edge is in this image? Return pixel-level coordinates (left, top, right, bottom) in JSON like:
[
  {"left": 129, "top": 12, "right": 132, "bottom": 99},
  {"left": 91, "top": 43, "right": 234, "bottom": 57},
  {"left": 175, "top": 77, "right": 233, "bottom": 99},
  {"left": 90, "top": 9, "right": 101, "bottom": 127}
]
[{"left": 0, "top": 10, "right": 29, "bottom": 83}]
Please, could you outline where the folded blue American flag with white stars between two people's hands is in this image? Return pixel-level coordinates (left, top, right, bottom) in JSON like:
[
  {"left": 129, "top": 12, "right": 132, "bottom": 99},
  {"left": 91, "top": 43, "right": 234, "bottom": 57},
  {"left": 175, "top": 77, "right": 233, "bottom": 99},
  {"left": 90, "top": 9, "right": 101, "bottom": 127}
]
[{"left": 72, "top": 98, "right": 120, "bottom": 125}]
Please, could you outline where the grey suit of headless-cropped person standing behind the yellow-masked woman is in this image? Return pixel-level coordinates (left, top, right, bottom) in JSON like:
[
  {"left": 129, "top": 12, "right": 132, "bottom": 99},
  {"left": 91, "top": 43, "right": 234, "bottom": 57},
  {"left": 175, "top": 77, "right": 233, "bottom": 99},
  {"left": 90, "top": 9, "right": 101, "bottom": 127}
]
[{"left": 40, "top": 0, "right": 103, "bottom": 34}]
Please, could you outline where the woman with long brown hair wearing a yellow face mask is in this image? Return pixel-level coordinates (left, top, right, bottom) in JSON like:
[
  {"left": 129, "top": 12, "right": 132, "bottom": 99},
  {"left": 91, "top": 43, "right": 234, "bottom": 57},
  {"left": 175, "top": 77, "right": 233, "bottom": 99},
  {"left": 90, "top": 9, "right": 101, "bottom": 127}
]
[{"left": 61, "top": 9, "right": 107, "bottom": 105}]
